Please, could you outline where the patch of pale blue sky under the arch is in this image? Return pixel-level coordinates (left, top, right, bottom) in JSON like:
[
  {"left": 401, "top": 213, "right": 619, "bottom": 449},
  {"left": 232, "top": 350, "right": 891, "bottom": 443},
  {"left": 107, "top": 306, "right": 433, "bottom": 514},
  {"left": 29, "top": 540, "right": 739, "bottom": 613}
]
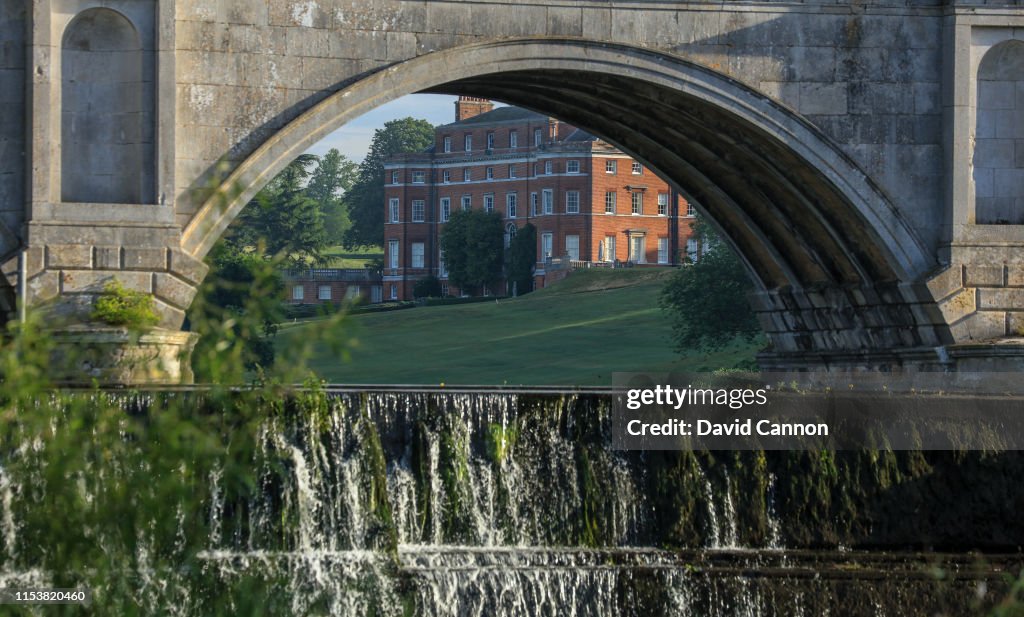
[{"left": 307, "top": 94, "right": 456, "bottom": 163}]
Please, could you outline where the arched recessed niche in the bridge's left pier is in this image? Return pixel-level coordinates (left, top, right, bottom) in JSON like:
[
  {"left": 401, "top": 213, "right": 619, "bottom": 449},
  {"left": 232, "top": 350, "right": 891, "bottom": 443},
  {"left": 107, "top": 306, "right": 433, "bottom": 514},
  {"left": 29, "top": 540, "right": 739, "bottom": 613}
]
[{"left": 60, "top": 8, "right": 154, "bottom": 204}]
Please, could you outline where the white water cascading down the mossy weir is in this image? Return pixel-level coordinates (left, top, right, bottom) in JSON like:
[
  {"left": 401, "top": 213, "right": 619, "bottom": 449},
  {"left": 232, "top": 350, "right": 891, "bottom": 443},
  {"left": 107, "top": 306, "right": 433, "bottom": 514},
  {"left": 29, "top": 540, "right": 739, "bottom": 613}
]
[{"left": 0, "top": 392, "right": 1011, "bottom": 617}]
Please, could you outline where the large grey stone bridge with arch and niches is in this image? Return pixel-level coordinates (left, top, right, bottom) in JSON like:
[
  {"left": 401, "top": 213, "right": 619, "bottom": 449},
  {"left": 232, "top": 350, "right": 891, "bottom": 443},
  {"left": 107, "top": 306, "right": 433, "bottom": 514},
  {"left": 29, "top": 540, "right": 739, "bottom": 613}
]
[{"left": 0, "top": 0, "right": 1024, "bottom": 376}]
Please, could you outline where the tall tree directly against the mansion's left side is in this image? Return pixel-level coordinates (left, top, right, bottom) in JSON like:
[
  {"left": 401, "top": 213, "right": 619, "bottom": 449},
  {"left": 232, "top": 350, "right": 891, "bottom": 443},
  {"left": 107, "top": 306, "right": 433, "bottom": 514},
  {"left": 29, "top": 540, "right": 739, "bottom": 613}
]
[{"left": 344, "top": 118, "right": 434, "bottom": 249}]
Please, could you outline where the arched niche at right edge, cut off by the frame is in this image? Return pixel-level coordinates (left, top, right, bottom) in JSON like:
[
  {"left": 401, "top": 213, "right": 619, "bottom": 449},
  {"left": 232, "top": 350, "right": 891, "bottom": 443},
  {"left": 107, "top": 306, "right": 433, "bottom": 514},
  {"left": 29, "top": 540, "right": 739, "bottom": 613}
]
[{"left": 974, "top": 40, "right": 1024, "bottom": 225}]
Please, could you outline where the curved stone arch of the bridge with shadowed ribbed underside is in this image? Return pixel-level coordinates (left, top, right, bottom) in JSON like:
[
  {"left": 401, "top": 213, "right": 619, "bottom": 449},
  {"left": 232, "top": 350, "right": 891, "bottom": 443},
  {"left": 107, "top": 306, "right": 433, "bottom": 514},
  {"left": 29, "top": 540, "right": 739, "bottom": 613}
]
[{"left": 182, "top": 38, "right": 951, "bottom": 362}]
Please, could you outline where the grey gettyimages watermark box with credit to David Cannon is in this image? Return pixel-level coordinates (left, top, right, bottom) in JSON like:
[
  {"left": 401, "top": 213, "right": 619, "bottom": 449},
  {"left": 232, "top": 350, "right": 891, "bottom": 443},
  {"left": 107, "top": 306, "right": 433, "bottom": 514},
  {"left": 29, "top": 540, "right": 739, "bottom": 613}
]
[{"left": 611, "top": 372, "right": 1024, "bottom": 450}]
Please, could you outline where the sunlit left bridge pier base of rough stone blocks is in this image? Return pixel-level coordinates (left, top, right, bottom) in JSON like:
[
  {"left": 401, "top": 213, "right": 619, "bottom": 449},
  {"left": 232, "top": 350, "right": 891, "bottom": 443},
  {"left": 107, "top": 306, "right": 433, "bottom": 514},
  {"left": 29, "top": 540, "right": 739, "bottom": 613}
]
[{"left": 3, "top": 222, "right": 208, "bottom": 385}]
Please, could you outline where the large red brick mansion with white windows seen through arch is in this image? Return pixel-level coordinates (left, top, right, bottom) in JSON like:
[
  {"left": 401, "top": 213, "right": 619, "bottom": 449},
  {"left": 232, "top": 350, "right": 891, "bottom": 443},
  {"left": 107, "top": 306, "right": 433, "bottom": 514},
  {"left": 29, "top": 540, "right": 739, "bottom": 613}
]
[{"left": 383, "top": 97, "right": 696, "bottom": 301}]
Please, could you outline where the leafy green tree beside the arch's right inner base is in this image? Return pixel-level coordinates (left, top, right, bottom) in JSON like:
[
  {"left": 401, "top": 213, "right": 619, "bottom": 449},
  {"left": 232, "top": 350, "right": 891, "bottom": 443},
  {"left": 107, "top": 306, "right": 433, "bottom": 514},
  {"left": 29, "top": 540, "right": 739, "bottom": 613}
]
[{"left": 659, "top": 219, "right": 762, "bottom": 352}]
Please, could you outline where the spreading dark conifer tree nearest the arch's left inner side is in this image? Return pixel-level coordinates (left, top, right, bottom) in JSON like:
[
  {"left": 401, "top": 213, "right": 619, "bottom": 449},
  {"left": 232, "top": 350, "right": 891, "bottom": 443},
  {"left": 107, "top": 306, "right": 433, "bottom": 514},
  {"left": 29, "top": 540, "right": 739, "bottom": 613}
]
[{"left": 227, "top": 155, "right": 328, "bottom": 267}]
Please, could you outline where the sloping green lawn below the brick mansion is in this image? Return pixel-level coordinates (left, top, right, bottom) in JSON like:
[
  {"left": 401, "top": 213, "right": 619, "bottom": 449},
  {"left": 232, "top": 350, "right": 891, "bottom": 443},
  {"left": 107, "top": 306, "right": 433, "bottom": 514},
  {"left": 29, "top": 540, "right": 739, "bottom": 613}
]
[{"left": 278, "top": 269, "right": 755, "bottom": 386}]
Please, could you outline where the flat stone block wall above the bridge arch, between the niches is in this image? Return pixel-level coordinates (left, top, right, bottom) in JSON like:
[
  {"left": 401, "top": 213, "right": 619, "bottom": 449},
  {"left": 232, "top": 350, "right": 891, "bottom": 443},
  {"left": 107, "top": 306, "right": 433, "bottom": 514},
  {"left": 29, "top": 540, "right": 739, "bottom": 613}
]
[{"left": 169, "top": 0, "right": 942, "bottom": 245}]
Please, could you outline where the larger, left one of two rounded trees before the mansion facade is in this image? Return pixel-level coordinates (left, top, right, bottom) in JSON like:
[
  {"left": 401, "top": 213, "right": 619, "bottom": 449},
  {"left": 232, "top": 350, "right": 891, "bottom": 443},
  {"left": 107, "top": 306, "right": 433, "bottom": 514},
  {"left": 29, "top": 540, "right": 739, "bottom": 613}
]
[{"left": 440, "top": 210, "right": 505, "bottom": 292}]
